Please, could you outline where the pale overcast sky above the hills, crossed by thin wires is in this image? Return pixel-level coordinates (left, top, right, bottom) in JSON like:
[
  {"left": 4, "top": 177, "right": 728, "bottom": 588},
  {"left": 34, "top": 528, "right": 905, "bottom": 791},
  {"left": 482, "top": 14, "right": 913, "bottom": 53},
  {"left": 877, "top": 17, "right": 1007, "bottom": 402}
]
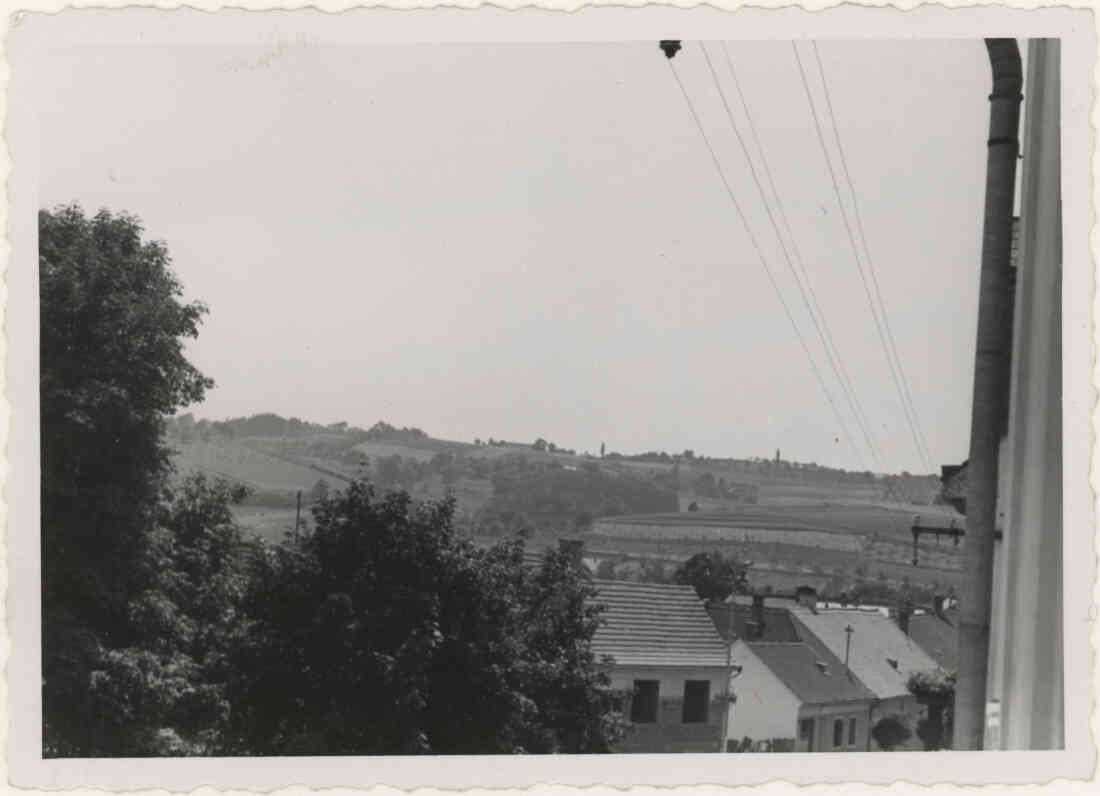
[{"left": 24, "top": 18, "right": 1003, "bottom": 472}]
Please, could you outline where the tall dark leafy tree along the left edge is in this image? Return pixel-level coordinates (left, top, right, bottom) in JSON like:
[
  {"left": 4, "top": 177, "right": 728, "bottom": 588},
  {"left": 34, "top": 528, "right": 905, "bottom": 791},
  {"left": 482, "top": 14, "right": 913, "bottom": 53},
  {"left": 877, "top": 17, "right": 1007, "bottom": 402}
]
[{"left": 39, "top": 206, "right": 212, "bottom": 754}]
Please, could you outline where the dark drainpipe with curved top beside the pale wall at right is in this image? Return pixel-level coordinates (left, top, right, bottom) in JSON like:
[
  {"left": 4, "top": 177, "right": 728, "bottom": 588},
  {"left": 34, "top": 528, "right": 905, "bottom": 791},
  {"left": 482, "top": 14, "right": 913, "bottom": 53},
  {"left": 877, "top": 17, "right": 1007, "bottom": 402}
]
[{"left": 955, "top": 38, "right": 1023, "bottom": 751}]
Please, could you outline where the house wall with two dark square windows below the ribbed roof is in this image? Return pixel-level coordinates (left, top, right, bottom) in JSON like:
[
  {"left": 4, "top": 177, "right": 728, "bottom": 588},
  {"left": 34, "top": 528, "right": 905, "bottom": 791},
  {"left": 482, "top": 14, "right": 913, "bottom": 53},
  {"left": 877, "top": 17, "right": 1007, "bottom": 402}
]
[{"left": 609, "top": 666, "right": 728, "bottom": 752}]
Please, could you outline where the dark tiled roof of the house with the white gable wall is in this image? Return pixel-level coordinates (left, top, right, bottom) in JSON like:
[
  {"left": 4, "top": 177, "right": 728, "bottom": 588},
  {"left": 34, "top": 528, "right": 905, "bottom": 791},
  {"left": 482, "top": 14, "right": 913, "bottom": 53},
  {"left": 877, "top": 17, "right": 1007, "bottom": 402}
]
[{"left": 749, "top": 642, "right": 875, "bottom": 705}]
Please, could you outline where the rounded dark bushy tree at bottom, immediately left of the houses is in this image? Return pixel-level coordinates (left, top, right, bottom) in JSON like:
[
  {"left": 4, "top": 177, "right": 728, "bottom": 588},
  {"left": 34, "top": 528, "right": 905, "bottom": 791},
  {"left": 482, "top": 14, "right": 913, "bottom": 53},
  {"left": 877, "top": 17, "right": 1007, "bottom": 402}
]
[{"left": 228, "top": 482, "right": 620, "bottom": 754}]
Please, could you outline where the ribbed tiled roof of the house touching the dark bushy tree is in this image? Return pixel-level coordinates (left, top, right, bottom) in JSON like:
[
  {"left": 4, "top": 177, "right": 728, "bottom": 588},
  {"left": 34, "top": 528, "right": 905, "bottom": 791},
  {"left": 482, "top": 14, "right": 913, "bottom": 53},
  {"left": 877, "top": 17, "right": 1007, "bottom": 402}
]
[{"left": 592, "top": 581, "right": 727, "bottom": 666}]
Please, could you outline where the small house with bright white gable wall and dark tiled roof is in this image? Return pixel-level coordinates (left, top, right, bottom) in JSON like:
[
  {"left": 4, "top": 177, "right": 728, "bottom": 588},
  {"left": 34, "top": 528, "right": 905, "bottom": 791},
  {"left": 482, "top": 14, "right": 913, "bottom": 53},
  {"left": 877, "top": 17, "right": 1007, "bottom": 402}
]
[{"left": 728, "top": 640, "right": 875, "bottom": 752}]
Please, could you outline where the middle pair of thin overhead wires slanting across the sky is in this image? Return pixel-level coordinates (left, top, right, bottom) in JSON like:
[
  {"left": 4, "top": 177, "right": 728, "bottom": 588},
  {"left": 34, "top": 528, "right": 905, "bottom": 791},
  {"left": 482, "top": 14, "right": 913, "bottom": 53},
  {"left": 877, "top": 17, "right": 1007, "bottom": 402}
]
[{"left": 700, "top": 43, "right": 882, "bottom": 466}]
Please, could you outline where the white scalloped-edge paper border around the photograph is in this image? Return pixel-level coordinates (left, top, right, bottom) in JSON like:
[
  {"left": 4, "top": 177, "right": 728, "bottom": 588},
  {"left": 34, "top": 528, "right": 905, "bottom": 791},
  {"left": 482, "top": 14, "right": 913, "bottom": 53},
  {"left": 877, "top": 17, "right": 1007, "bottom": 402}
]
[{"left": 0, "top": 0, "right": 1100, "bottom": 793}]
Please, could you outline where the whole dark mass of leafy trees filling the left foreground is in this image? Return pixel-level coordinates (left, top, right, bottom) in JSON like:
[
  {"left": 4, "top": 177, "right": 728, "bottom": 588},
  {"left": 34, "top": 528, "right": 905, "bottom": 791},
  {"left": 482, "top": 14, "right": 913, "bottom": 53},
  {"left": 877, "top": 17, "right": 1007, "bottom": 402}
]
[{"left": 40, "top": 207, "right": 622, "bottom": 756}]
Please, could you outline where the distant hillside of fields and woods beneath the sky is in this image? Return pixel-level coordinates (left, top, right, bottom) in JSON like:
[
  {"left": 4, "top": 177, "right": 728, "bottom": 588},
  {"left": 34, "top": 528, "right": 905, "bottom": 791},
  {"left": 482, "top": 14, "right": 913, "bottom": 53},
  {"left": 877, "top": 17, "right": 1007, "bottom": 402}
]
[{"left": 169, "top": 414, "right": 959, "bottom": 587}]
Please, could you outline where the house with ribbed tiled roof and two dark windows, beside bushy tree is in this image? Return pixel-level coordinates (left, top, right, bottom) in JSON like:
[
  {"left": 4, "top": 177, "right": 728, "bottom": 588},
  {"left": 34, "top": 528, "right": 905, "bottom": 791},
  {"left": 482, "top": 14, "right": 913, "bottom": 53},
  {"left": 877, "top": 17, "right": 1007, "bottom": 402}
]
[{"left": 592, "top": 579, "right": 729, "bottom": 752}]
